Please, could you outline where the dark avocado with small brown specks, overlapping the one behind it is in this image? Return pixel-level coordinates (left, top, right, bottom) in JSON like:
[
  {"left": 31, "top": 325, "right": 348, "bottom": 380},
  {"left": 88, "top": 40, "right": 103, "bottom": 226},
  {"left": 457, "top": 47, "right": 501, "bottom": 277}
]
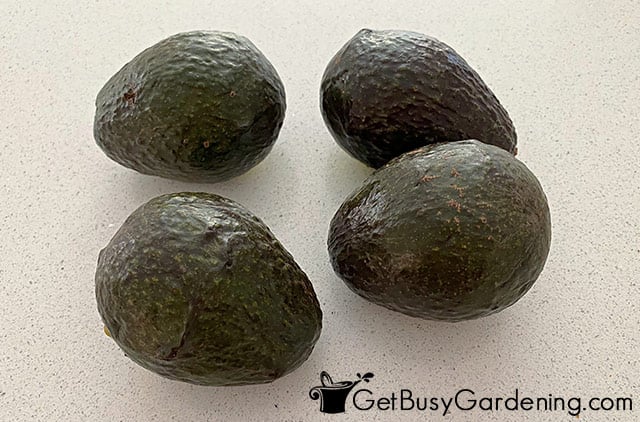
[{"left": 328, "top": 140, "right": 551, "bottom": 322}]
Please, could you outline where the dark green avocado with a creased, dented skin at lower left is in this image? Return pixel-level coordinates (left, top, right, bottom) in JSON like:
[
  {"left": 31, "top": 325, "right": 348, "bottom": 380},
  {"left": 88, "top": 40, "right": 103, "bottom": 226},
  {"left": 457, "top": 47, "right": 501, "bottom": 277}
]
[{"left": 95, "top": 193, "right": 322, "bottom": 386}]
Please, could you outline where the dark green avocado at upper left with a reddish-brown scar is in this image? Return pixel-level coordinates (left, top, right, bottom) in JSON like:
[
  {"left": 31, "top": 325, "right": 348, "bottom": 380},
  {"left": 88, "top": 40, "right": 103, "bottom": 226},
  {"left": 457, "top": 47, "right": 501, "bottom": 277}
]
[{"left": 94, "top": 31, "right": 286, "bottom": 183}]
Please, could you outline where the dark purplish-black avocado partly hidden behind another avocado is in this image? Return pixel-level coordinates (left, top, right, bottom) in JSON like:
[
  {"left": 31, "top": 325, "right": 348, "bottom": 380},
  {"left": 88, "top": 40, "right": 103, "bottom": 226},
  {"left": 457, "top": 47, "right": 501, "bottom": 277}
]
[{"left": 320, "top": 29, "right": 517, "bottom": 168}]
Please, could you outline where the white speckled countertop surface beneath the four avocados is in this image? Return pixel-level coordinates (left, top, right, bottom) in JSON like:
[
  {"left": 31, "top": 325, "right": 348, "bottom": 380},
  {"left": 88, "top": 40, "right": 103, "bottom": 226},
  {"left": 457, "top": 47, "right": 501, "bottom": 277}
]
[{"left": 0, "top": 0, "right": 640, "bottom": 421}]
